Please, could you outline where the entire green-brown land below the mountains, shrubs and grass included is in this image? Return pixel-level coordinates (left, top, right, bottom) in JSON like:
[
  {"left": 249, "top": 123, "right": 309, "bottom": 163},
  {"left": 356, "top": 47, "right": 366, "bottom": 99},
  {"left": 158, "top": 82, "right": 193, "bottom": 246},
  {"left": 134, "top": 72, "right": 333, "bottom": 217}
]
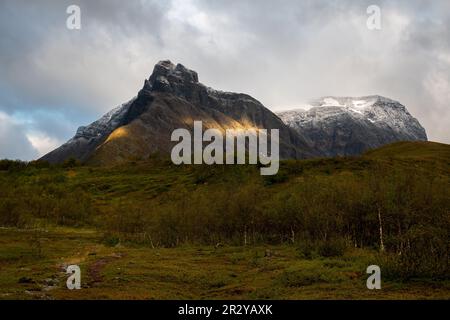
[{"left": 0, "top": 142, "right": 450, "bottom": 299}]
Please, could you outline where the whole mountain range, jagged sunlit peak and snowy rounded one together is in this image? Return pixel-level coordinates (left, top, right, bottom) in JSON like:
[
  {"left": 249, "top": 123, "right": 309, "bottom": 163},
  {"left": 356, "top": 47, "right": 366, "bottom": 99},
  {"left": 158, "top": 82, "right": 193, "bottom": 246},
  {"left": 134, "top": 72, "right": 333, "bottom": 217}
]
[{"left": 41, "top": 60, "right": 427, "bottom": 164}]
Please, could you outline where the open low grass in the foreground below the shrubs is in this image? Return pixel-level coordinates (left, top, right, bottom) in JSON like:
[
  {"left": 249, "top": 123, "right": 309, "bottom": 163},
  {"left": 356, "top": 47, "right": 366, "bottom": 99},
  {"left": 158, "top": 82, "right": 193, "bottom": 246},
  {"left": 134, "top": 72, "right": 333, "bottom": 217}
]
[{"left": 0, "top": 228, "right": 450, "bottom": 299}]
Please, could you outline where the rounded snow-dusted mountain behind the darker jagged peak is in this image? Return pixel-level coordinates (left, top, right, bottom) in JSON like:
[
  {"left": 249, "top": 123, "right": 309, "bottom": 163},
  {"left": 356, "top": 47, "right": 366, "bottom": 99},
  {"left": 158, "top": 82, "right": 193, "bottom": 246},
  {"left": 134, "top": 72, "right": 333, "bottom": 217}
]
[{"left": 277, "top": 96, "right": 427, "bottom": 156}]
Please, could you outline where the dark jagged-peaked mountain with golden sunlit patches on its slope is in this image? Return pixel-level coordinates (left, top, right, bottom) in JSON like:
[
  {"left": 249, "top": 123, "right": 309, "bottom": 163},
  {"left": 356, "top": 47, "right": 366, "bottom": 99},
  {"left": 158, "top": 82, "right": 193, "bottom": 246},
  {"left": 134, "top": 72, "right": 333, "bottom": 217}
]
[{"left": 41, "top": 60, "right": 320, "bottom": 164}]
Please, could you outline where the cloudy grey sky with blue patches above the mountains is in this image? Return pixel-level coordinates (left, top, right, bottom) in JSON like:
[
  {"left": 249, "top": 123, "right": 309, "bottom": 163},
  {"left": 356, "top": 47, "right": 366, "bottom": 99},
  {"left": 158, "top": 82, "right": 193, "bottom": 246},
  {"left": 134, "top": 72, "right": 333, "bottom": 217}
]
[{"left": 0, "top": 0, "right": 450, "bottom": 160}]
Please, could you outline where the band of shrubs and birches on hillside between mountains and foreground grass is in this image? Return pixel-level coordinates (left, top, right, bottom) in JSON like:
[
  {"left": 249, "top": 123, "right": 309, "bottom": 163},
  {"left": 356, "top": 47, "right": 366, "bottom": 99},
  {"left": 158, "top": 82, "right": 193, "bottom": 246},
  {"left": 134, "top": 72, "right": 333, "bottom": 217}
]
[{"left": 0, "top": 143, "right": 450, "bottom": 281}]
